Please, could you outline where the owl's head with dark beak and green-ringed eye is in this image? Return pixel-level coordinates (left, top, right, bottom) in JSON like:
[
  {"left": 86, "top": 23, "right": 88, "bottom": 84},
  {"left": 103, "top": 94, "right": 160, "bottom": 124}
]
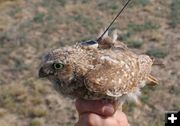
[{"left": 39, "top": 52, "right": 73, "bottom": 83}]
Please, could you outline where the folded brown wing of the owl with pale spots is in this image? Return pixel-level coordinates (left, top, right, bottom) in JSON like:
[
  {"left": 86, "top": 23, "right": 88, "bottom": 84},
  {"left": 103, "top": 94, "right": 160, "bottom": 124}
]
[{"left": 86, "top": 52, "right": 138, "bottom": 97}]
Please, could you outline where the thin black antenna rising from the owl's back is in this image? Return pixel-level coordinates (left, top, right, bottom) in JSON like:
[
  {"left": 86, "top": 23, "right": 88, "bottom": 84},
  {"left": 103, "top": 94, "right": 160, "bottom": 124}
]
[{"left": 97, "top": 0, "right": 131, "bottom": 42}]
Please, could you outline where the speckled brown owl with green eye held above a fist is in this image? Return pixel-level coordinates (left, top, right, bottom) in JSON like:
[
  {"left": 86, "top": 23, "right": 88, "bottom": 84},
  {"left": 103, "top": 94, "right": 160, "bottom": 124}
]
[{"left": 39, "top": 33, "right": 157, "bottom": 107}]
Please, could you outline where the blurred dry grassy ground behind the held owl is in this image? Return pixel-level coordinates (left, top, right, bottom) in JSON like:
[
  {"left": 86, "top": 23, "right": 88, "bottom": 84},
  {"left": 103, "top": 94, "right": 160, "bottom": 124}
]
[{"left": 0, "top": 0, "right": 180, "bottom": 126}]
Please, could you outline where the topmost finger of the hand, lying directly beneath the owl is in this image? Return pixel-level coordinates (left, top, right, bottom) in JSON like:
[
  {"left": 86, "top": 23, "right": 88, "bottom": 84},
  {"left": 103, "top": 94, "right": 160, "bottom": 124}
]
[{"left": 76, "top": 99, "right": 115, "bottom": 116}]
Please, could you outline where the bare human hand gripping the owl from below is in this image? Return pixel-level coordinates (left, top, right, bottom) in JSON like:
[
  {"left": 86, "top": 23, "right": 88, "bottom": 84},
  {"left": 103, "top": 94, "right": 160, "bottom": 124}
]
[{"left": 75, "top": 99, "right": 129, "bottom": 126}]
